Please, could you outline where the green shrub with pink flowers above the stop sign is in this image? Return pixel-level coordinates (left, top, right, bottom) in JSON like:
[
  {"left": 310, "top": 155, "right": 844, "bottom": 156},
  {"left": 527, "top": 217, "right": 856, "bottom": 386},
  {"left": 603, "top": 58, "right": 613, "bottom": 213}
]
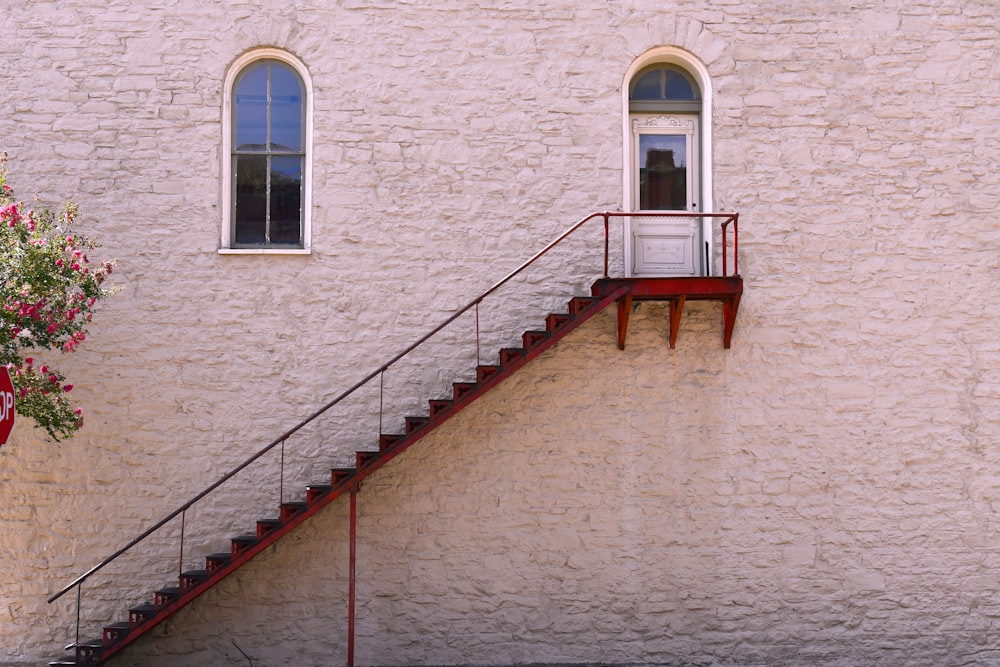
[{"left": 0, "top": 153, "right": 115, "bottom": 440}]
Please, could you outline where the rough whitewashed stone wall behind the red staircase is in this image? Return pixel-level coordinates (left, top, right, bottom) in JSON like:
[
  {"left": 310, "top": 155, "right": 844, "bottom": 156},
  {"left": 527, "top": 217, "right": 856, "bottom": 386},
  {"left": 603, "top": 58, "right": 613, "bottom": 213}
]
[{"left": 0, "top": 0, "right": 1000, "bottom": 665}]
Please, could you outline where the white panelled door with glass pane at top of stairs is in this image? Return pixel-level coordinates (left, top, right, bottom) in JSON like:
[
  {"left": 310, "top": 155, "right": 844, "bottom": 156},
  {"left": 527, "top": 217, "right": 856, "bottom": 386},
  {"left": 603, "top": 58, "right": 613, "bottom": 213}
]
[{"left": 626, "top": 114, "right": 705, "bottom": 277}]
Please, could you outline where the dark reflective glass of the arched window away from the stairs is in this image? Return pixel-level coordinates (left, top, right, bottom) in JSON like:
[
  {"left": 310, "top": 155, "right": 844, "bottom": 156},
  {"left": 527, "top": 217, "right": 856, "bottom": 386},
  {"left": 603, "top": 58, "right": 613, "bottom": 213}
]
[{"left": 232, "top": 60, "right": 305, "bottom": 247}]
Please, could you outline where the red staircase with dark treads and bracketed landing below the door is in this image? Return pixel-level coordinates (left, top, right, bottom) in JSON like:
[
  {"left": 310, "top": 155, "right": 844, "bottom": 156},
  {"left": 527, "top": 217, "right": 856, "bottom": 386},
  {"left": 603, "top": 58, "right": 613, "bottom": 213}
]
[{"left": 49, "top": 214, "right": 743, "bottom": 666}]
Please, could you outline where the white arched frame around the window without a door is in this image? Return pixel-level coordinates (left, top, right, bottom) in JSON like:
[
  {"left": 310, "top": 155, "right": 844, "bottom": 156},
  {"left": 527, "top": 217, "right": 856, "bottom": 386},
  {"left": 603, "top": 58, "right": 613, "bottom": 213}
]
[{"left": 219, "top": 48, "right": 313, "bottom": 255}]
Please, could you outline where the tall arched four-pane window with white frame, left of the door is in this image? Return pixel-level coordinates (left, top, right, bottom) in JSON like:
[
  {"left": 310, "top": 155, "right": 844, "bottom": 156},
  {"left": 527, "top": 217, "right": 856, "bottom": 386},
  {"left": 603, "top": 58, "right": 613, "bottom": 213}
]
[{"left": 222, "top": 49, "right": 312, "bottom": 252}]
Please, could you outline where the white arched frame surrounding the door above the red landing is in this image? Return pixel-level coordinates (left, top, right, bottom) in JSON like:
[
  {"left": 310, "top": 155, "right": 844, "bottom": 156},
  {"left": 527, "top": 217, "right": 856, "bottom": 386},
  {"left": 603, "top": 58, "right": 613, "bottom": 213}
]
[{"left": 621, "top": 46, "right": 715, "bottom": 275}]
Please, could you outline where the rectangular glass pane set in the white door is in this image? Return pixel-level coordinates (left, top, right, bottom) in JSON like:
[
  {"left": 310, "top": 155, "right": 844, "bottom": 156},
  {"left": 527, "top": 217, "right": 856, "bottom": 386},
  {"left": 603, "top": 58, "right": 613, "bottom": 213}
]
[{"left": 639, "top": 134, "right": 688, "bottom": 211}]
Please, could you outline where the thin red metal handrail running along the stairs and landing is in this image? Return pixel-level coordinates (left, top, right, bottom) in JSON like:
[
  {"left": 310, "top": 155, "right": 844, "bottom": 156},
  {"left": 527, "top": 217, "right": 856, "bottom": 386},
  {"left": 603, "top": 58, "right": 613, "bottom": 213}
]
[{"left": 48, "top": 211, "right": 739, "bottom": 642}]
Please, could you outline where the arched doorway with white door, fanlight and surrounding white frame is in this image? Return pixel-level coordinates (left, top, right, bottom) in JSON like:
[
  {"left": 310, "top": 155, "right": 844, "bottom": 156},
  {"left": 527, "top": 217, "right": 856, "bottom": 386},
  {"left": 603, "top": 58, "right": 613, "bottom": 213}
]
[{"left": 622, "top": 47, "right": 712, "bottom": 276}]
